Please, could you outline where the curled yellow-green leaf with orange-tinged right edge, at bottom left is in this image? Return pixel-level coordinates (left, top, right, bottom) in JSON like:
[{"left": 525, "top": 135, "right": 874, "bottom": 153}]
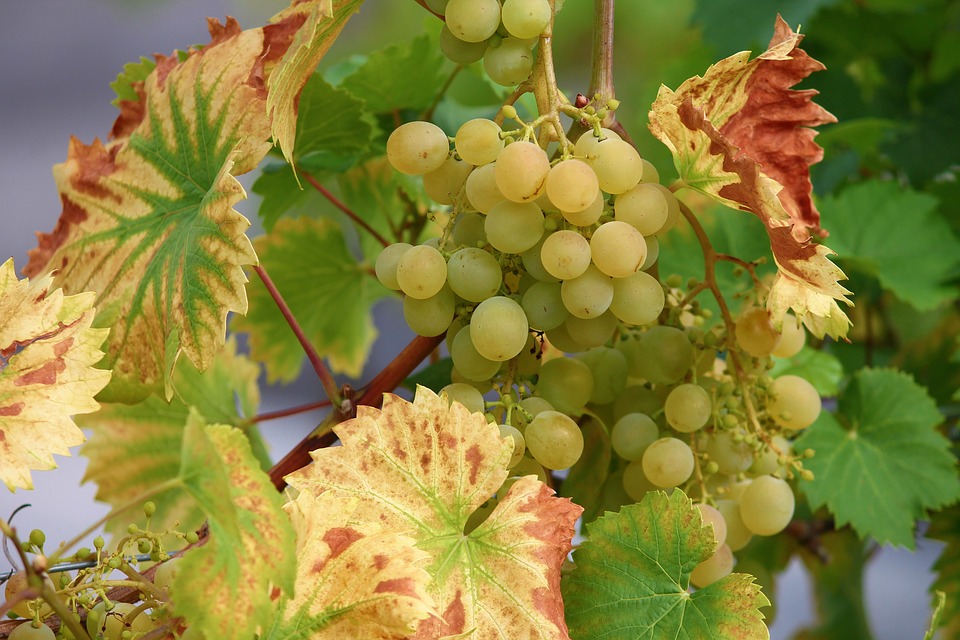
[{"left": 170, "top": 412, "right": 297, "bottom": 640}]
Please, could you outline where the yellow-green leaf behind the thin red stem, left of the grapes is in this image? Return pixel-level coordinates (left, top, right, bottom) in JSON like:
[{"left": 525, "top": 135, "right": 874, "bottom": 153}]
[{"left": 233, "top": 218, "right": 390, "bottom": 382}]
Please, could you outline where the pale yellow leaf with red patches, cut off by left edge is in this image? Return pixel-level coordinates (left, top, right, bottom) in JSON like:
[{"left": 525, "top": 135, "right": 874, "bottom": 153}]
[{"left": 0, "top": 258, "right": 110, "bottom": 491}]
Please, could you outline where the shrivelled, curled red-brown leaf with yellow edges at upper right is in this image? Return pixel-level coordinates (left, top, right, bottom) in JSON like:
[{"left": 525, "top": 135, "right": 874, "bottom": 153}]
[{"left": 650, "top": 16, "right": 850, "bottom": 337}]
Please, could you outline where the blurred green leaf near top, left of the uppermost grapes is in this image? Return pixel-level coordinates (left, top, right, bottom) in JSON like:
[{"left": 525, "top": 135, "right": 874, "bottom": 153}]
[{"left": 340, "top": 35, "right": 450, "bottom": 113}]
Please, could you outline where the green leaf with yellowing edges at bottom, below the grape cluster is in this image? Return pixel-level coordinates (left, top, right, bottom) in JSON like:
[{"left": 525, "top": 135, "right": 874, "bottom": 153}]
[{"left": 563, "top": 490, "right": 770, "bottom": 640}]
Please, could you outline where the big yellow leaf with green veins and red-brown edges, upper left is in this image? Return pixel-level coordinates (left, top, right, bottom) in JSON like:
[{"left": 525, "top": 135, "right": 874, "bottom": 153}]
[{"left": 24, "top": 0, "right": 364, "bottom": 402}]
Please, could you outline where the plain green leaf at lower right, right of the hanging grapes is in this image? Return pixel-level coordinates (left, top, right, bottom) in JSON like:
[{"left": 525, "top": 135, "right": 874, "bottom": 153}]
[{"left": 795, "top": 369, "right": 960, "bottom": 549}]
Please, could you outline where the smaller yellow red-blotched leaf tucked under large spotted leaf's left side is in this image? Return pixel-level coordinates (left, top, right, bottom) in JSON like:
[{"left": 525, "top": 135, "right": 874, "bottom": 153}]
[{"left": 264, "top": 491, "right": 437, "bottom": 640}]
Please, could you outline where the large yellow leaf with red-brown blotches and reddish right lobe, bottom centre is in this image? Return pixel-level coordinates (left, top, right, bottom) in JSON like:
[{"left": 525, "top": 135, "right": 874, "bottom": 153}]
[{"left": 287, "top": 387, "right": 582, "bottom": 640}]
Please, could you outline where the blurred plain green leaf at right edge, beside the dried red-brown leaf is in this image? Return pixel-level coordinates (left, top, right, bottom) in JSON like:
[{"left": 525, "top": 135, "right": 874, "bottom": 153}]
[{"left": 823, "top": 180, "right": 960, "bottom": 310}]
